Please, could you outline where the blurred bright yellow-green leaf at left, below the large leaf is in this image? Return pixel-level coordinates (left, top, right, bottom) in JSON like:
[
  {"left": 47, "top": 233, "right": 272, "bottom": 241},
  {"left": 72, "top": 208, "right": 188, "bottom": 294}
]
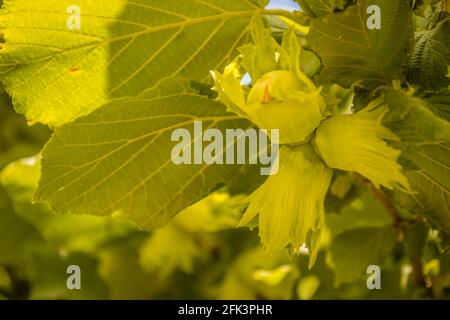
[{"left": 0, "top": 157, "right": 138, "bottom": 253}]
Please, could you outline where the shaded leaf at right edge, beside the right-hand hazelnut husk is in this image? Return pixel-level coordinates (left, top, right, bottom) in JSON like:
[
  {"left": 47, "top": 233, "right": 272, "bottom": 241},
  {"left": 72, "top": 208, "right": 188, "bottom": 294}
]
[{"left": 386, "top": 91, "right": 450, "bottom": 232}]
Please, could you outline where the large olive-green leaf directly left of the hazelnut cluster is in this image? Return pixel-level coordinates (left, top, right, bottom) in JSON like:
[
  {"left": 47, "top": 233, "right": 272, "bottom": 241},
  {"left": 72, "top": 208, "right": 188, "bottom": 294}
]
[{"left": 36, "top": 81, "right": 251, "bottom": 228}]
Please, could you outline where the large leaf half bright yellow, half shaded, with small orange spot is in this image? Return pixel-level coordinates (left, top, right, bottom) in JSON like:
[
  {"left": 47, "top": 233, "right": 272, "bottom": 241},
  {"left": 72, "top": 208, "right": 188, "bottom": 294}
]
[{"left": 0, "top": 0, "right": 264, "bottom": 127}]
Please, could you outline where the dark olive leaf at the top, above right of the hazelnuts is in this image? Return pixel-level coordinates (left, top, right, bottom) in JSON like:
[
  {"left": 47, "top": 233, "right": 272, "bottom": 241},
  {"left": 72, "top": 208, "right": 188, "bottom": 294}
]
[{"left": 308, "top": 0, "right": 413, "bottom": 87}]
